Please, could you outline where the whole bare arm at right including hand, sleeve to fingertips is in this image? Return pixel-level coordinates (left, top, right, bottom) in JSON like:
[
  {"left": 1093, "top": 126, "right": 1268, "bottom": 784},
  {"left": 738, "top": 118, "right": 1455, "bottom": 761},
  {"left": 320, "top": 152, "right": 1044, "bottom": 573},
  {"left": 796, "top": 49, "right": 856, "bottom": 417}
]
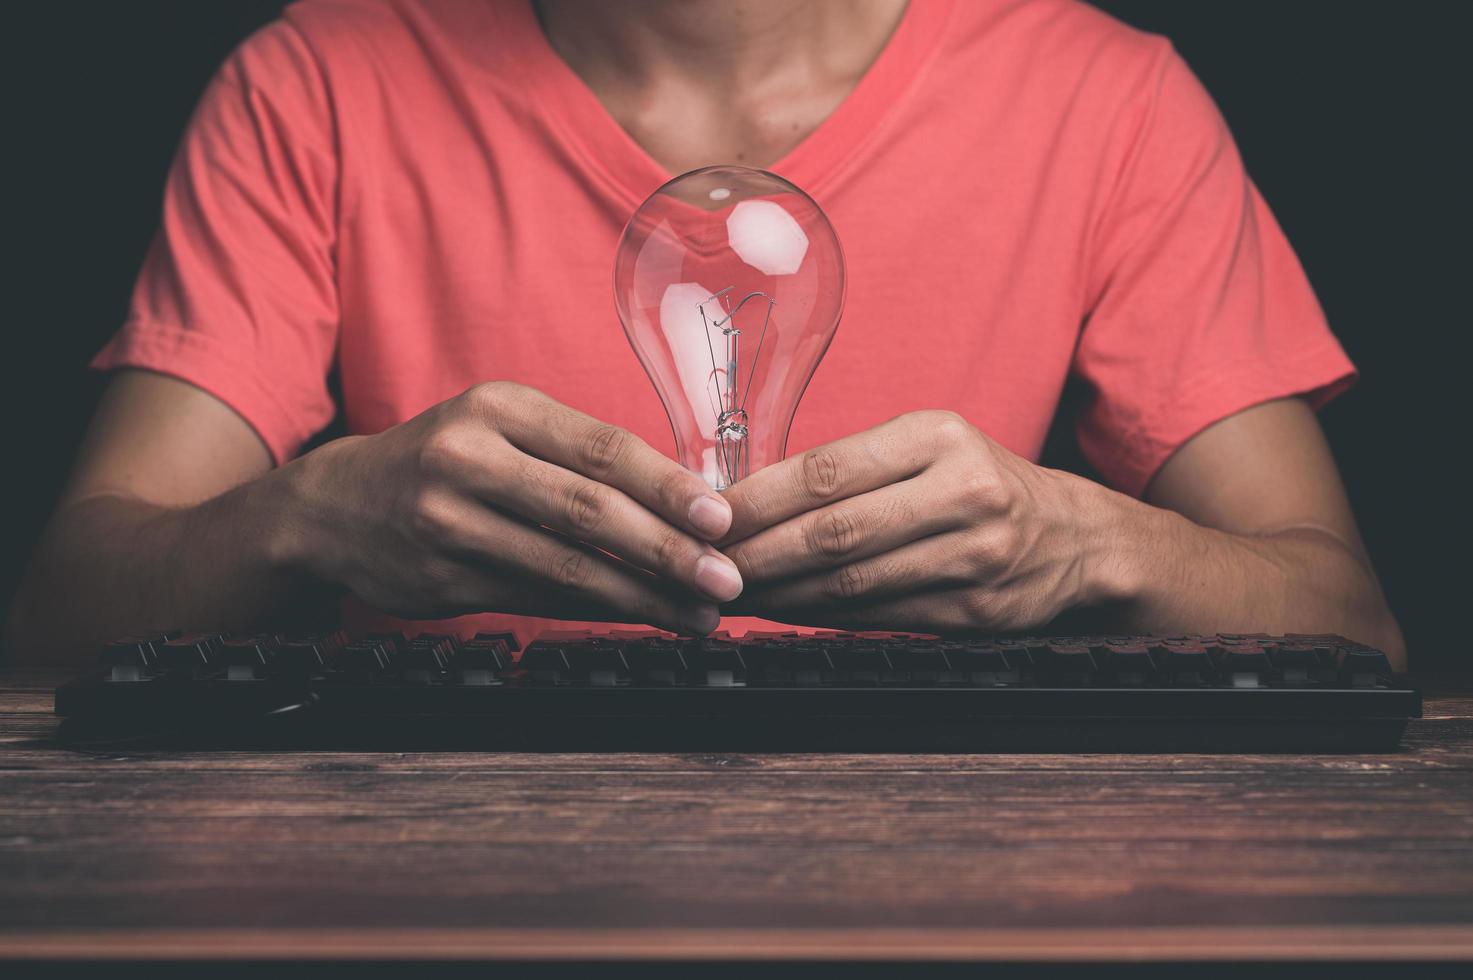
[{"left": 725, "top": 399, "right": 1405, "bottom": 666}]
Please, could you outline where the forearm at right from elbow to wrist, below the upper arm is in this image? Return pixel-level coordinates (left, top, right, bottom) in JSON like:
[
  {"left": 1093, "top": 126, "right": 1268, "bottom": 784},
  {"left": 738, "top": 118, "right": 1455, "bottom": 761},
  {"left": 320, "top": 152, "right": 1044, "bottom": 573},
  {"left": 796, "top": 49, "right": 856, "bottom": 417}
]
[{"left": 1075, "top": 480, "right": 1405, "bottom": 666}]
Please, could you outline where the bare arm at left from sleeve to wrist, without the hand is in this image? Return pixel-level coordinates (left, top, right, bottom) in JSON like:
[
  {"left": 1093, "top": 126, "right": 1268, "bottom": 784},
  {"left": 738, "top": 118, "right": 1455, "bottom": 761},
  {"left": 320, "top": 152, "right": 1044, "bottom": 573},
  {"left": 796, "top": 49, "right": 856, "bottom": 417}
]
[{"left": 4, "top": 371, "right": 300, "bottom": 660}]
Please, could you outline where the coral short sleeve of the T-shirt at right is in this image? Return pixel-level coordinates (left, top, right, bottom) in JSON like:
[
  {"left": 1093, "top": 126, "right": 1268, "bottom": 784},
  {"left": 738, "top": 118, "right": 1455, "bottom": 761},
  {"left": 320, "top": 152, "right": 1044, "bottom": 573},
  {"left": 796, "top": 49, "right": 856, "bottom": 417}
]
[{"left": 1074, "top": 40, "right": 1355, "bottom": 497}]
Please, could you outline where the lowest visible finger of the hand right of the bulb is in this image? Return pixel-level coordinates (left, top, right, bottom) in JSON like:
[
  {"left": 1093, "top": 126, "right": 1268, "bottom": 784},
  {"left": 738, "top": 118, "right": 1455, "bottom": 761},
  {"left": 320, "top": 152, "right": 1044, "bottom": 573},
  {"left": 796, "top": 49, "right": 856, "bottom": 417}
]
[{"left": 728, "top": 533, "right": 975, "bottom": 619}]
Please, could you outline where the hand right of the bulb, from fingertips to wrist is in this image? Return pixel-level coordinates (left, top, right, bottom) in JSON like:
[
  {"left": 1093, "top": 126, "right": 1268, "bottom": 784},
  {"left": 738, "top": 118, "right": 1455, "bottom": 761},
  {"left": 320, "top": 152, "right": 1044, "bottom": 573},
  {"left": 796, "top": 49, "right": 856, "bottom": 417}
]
[{"left": 717, "top": 411, "right": 1100, "bottom": 632}]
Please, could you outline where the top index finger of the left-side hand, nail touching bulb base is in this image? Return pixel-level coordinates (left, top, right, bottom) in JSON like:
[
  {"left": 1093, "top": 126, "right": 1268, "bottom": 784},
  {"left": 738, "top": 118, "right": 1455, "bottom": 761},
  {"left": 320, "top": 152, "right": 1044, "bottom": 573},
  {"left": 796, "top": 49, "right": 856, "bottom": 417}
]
[{"left": 483, "top": 386, "right": 731, "bottom": 541}]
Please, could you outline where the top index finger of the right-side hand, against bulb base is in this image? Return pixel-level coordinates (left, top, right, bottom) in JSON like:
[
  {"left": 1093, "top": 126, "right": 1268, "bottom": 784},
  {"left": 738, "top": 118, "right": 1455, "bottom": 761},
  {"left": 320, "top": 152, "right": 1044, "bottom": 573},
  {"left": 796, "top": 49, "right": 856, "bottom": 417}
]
[{"left": 722, "top": 416, "right": 931, "bottom": 544}]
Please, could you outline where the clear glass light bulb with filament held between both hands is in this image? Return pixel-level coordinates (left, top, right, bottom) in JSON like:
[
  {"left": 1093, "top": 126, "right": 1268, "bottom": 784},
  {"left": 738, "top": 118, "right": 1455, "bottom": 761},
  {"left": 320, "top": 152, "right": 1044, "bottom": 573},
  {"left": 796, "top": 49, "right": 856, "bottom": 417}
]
[{"left": 614, "top": 167, "right": 844, "bottom": 489}]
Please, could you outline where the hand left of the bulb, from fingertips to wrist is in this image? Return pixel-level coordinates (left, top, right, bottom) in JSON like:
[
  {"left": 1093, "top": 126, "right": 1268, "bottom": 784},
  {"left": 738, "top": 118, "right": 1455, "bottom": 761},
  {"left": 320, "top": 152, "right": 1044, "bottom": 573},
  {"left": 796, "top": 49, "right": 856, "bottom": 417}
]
[{"left": 292, "top": 382, "right": 741, "bottom": 632}]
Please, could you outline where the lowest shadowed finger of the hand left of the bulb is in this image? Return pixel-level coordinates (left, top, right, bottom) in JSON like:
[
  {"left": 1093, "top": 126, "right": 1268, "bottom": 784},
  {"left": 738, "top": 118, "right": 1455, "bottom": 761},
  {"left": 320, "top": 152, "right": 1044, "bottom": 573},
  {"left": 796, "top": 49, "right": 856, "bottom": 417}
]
[{"left": 427, "top": 498, "right": 720, "bottom": 634}]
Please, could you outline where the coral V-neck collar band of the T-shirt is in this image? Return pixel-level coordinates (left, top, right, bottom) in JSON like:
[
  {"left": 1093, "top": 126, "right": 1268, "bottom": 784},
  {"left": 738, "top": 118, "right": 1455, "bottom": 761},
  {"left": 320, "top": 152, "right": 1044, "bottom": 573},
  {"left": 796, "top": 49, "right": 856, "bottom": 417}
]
[{"left": 498, "top": 0, "right": 955, "bottom": 208}]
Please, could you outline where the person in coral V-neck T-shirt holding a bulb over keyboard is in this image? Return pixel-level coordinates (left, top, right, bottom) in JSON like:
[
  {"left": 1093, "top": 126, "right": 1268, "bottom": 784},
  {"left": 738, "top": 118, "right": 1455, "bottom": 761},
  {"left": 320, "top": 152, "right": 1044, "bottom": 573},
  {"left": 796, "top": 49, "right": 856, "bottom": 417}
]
[{"left": 0, "top": 0, "right": 1404, "bottom": 665}]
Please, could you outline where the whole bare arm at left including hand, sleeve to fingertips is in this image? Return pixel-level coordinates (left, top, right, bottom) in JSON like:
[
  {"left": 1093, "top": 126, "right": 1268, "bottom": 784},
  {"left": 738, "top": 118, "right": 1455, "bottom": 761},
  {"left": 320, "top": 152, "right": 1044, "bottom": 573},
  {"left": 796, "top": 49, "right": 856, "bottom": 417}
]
[{"left": 6, "top": 371, "right": 741, "bottom": 659}]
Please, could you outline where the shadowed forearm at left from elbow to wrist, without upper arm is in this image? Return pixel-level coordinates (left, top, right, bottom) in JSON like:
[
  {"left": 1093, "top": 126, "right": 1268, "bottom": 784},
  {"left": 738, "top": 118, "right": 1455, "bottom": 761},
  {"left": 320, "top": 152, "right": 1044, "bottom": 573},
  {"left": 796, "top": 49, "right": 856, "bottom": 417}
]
[{"left": 4, "top": 467, "right": 321, "bottom": 662}]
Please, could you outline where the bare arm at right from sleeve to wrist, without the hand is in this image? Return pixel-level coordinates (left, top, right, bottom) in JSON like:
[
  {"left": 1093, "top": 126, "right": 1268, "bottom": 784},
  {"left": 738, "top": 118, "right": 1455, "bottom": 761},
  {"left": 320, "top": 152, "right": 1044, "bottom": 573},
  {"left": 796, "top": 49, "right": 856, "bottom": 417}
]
[{"left": 1107, "top": 399, "right": 1407, "bottom": 669}]
